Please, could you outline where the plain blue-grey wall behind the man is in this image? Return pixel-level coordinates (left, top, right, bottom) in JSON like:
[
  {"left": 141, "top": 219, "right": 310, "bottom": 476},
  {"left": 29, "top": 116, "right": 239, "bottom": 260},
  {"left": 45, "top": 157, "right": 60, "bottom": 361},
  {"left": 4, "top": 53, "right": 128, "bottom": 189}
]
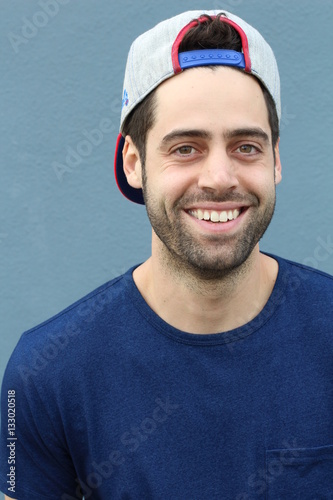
[{"left": 0, "top": 0, "right": 333, "bottom": 484}]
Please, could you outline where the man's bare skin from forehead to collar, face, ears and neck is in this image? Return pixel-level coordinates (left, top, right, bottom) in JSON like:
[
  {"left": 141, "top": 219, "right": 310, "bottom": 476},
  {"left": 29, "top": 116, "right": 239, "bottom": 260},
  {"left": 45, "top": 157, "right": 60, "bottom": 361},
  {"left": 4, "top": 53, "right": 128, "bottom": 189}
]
[{"left": 123, "top": 62, "right": 281, "bottom": 333}]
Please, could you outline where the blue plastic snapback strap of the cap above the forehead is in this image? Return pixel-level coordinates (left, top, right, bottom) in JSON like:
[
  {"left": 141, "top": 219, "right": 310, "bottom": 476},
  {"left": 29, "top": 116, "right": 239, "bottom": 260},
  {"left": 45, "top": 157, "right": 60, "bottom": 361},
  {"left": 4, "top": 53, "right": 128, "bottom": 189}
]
[{"left": 178, "top": 49, "right": 245, "bottom": 69}]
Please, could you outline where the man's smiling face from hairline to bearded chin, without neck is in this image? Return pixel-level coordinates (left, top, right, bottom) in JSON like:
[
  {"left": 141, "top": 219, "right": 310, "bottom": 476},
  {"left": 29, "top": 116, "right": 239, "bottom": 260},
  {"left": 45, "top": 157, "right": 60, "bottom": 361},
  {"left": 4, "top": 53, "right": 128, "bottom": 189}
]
[{"left": 132, "top": 67, "right": 281, "bottom": 278}]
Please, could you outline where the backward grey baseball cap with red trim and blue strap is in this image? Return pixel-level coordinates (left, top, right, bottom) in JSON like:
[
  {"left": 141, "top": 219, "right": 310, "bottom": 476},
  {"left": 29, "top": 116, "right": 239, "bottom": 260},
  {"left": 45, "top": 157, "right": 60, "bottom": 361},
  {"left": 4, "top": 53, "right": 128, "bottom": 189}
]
[{"left": 114, "top": 10, "right": 281, "bottom": 204}]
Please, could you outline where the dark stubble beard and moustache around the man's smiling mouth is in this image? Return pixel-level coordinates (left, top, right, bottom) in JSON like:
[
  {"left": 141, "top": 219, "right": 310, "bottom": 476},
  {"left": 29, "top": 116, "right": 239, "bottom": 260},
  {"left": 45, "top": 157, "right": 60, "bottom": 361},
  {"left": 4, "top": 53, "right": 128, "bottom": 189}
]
[{"left": 142, "top": 172, "right": 276, "bottom": 280}]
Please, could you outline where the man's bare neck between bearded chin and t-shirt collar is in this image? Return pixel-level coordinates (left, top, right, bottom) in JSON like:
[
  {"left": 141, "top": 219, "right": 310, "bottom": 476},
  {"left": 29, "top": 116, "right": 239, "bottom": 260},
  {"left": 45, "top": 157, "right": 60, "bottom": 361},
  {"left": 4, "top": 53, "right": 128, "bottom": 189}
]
[{"left": 133, "top": 237, "right": 278, "bottom": 334}]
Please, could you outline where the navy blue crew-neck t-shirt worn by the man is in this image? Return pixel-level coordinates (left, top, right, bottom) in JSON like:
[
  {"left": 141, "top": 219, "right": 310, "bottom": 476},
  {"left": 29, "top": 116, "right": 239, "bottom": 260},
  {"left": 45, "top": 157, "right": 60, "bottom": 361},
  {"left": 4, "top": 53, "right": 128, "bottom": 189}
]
[{"left": 0, "top": 257, "right": 333, "bottom": 500}]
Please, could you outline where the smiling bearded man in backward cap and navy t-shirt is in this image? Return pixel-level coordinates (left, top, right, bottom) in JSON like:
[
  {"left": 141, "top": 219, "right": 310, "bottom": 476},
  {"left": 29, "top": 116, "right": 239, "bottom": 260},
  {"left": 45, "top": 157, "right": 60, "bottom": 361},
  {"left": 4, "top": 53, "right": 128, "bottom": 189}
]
[{"left": 0, "top": 7, "right": 333, "bottom": 500}]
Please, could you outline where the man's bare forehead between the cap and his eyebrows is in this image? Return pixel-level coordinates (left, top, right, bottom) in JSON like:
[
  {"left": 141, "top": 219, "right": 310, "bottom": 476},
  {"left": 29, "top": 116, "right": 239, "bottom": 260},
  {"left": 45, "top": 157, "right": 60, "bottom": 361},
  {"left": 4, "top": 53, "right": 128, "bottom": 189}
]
[{"left": 153, "top": 67, "right": 270, "bottom": 138}]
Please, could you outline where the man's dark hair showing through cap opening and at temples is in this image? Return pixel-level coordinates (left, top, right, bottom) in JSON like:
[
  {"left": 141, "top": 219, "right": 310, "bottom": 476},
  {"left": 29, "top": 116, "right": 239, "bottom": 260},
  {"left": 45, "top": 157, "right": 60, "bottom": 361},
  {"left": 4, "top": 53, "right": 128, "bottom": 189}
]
[{"left": 123, "top": 13, "right": 279, "bottom": 165}]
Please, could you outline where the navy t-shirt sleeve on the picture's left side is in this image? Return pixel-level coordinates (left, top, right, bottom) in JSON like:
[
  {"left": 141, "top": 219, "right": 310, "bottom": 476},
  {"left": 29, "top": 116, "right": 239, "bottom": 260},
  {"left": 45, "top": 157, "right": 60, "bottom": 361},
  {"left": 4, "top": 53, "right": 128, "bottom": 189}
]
[{"left": 0, "top": 338, "right": 82, "bottom": 500}]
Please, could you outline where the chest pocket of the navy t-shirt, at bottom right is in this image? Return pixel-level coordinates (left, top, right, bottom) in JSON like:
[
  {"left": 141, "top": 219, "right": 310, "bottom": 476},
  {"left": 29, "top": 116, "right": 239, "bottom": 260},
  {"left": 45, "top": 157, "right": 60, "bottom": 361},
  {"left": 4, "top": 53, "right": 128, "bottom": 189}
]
[{"left": 266, "top": 445, "right": 333, "bottom": 500}]
